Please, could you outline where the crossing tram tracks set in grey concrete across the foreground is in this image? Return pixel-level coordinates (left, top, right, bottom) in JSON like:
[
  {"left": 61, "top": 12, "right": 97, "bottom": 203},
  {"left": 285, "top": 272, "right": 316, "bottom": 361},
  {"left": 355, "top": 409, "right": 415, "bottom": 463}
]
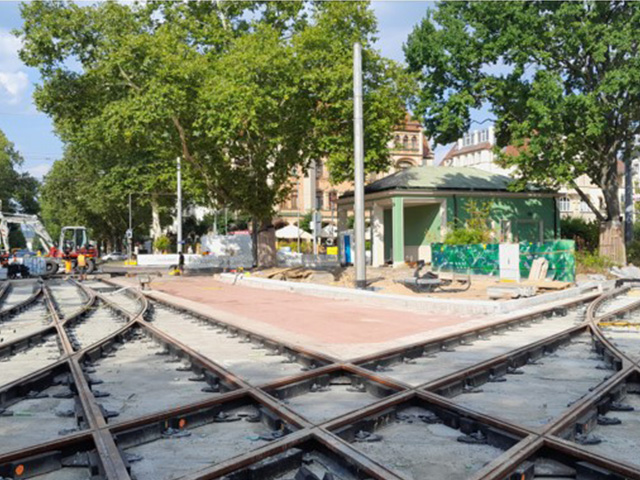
[{"left": 0, "top": 282, "right": 640, "bottom": 480}]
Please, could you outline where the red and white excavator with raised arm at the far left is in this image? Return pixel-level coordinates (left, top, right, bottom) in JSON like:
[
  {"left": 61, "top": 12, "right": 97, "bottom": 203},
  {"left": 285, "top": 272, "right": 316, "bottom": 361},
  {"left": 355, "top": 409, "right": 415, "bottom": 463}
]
[{"left": 0, "top": 212, "right": 98, "bottom": 275}]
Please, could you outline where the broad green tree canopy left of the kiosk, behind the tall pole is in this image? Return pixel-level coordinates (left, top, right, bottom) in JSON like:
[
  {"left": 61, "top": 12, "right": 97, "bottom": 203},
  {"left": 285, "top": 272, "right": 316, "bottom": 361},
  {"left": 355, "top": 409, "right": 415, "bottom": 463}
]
[{"left": 19, "top": 2, "right": 411, "bottom": 260}]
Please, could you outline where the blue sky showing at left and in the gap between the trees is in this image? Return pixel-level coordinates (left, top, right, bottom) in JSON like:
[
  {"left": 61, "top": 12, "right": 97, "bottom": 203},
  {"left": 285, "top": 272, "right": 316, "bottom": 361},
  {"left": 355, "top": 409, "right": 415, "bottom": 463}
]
[{"left": 0, "top": 0, "right": 443, "bottom": 177}]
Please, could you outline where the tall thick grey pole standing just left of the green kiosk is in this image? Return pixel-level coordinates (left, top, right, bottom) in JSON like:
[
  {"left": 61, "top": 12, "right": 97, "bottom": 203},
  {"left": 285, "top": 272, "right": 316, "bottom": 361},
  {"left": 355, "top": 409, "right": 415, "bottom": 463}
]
[{"left": 353, "top": 42, "right": 367, "bottom": 288}]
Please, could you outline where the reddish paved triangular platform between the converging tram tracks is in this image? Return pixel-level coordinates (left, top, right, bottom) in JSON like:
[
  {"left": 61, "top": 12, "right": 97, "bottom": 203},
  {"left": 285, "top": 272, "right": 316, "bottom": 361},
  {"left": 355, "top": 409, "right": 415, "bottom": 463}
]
[{"left": 136, "top": 277, "right": 486, "bottom": 353}]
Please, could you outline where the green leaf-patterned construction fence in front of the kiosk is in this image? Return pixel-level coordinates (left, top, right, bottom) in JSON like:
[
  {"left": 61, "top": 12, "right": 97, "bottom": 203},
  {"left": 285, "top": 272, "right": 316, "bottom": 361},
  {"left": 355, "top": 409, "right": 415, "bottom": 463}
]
[{"left": 431, "top": 240, "right": 576, "bottom": 283}]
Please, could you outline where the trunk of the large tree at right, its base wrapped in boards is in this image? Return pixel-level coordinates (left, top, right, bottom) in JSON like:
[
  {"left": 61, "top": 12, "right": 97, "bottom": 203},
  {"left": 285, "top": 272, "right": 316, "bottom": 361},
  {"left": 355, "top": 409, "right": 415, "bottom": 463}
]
[{"left": 600, "top": 179, "right": 627, "bottom": 265}]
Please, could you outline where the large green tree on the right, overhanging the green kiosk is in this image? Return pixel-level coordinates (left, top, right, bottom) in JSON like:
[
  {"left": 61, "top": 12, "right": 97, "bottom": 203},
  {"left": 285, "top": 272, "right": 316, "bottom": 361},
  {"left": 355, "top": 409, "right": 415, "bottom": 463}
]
[{"left": 405, "top": 1, "right": 640, "bottom": 263}]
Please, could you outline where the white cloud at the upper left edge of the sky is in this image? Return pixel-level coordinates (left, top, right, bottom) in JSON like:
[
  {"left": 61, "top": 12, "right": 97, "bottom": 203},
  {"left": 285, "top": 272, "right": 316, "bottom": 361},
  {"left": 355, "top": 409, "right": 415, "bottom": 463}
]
[{"left": 0, "top": 29, "right": 29, "bottom": 105}]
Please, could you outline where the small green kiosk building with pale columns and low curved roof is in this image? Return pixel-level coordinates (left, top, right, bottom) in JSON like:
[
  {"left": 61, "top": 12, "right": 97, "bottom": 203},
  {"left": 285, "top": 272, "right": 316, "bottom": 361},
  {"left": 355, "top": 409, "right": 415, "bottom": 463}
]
[{"left": 338, "top": 167, "right": 560, "bottom": 266}]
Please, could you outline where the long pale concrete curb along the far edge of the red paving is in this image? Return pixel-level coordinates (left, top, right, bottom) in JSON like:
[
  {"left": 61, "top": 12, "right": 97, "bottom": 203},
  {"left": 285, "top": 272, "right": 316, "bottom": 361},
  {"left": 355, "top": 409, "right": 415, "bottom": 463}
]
[{"left": 219, "top": 273, "right": 609, "bottom": 315}]
